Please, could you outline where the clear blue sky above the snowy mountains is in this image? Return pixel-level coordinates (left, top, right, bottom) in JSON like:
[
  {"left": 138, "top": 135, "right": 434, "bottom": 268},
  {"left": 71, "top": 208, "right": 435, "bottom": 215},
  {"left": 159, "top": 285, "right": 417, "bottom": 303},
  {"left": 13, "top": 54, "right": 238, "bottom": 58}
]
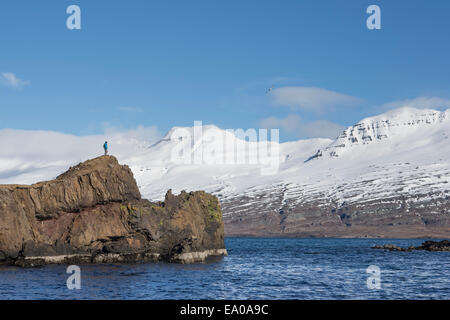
[{"left": 0, "top": 0, "right": 450, "bottom": 141}]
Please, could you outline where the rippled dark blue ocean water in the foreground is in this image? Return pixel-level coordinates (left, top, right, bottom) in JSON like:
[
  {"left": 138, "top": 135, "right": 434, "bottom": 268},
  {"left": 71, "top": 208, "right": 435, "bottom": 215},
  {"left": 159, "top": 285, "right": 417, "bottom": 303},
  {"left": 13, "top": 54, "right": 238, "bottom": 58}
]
[{"left": 0, "top": 238, "right": 450, "bottom": 299}]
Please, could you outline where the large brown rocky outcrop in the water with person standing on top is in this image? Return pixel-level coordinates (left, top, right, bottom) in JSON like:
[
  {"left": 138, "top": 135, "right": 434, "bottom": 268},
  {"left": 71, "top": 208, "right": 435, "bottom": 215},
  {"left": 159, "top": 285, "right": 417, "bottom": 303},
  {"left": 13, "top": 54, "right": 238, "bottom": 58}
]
[{"left": 0, "top": 156, "right": 226, "bottom": 266}]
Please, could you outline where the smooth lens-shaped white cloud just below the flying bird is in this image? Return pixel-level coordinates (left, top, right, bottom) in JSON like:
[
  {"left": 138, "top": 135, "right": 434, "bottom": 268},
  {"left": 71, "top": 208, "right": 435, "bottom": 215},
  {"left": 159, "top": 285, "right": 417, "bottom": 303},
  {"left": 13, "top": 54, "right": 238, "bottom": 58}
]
[{"left": 271, "top": 87, "right": 361, "bottom": 112}]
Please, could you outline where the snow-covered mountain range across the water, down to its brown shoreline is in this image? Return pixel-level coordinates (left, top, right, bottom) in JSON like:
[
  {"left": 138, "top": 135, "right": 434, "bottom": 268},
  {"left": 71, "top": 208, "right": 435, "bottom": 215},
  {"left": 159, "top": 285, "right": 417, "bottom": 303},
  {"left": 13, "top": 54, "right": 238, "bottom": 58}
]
[{"left": 0, "top": 108, "right": 450, "bottom": 237}]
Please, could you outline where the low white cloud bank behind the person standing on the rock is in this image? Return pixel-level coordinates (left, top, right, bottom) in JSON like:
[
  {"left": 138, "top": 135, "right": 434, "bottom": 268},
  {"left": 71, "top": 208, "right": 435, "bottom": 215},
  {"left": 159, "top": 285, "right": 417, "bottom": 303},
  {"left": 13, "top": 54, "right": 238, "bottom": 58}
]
[{"left": 0, "top": 126, "right": 161, "bottom": 184}]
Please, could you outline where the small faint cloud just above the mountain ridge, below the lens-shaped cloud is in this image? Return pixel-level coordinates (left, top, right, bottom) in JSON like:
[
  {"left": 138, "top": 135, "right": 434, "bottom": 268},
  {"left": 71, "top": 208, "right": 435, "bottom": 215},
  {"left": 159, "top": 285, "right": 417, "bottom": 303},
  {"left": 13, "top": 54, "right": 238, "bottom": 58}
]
[{"left": 259, "top": 114, "right": 345, "bottom": 139}]
